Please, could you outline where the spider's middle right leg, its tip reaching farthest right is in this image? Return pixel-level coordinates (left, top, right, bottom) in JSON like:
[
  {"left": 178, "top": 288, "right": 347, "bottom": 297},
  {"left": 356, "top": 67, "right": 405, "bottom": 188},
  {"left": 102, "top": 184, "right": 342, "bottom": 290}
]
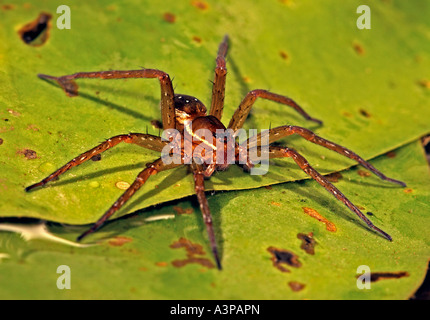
[{"left": 248, "top": 126, "right": 406, "bottom": 187}]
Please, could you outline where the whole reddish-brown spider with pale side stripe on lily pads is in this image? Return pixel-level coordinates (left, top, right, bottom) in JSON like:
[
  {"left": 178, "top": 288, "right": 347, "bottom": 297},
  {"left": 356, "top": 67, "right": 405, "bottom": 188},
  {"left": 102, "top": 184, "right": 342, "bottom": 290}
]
[{"left": 25, "top": 35, "right": 406, "bottom": 270}]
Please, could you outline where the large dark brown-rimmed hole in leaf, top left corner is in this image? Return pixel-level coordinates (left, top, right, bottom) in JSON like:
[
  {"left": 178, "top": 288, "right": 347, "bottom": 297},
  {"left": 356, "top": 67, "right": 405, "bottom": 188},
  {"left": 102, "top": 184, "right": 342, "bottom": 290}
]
[{"left": 18, "top": 12, "right": 52, "bottom": 46}]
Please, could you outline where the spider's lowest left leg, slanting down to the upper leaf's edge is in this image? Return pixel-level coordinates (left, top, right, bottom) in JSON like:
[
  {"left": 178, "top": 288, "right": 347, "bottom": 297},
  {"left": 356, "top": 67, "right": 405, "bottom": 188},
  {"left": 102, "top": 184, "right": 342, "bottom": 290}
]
[{"left": 77, "top": 158, "right": 178, "bottom": 241}]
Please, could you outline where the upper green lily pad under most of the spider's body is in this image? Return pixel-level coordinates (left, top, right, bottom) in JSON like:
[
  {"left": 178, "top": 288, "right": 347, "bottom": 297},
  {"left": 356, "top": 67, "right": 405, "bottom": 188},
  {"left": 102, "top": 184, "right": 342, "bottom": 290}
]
[{"left": 0, "top": 1, "right": 430, "bottom": 224}]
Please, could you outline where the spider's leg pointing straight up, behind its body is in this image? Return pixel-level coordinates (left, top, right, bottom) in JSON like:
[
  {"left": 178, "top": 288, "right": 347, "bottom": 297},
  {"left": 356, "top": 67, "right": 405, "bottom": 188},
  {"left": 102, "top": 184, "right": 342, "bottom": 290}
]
[{"left": 209, "top": 35, "right": 228, "bottom": 120}]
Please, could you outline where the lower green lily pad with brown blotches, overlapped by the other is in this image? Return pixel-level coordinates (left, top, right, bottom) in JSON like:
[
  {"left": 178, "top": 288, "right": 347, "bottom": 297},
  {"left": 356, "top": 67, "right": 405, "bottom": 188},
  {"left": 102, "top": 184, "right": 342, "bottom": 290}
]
[{"left": 0, "top": 143, "right": 430, "bottom": 299}]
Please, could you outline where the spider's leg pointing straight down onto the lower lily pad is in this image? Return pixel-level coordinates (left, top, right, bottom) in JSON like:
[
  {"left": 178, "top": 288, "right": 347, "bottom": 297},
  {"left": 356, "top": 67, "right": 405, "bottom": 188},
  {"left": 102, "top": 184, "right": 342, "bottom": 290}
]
[{"left": 192, "top": 163, "right": 222, "bottom": 270}]
